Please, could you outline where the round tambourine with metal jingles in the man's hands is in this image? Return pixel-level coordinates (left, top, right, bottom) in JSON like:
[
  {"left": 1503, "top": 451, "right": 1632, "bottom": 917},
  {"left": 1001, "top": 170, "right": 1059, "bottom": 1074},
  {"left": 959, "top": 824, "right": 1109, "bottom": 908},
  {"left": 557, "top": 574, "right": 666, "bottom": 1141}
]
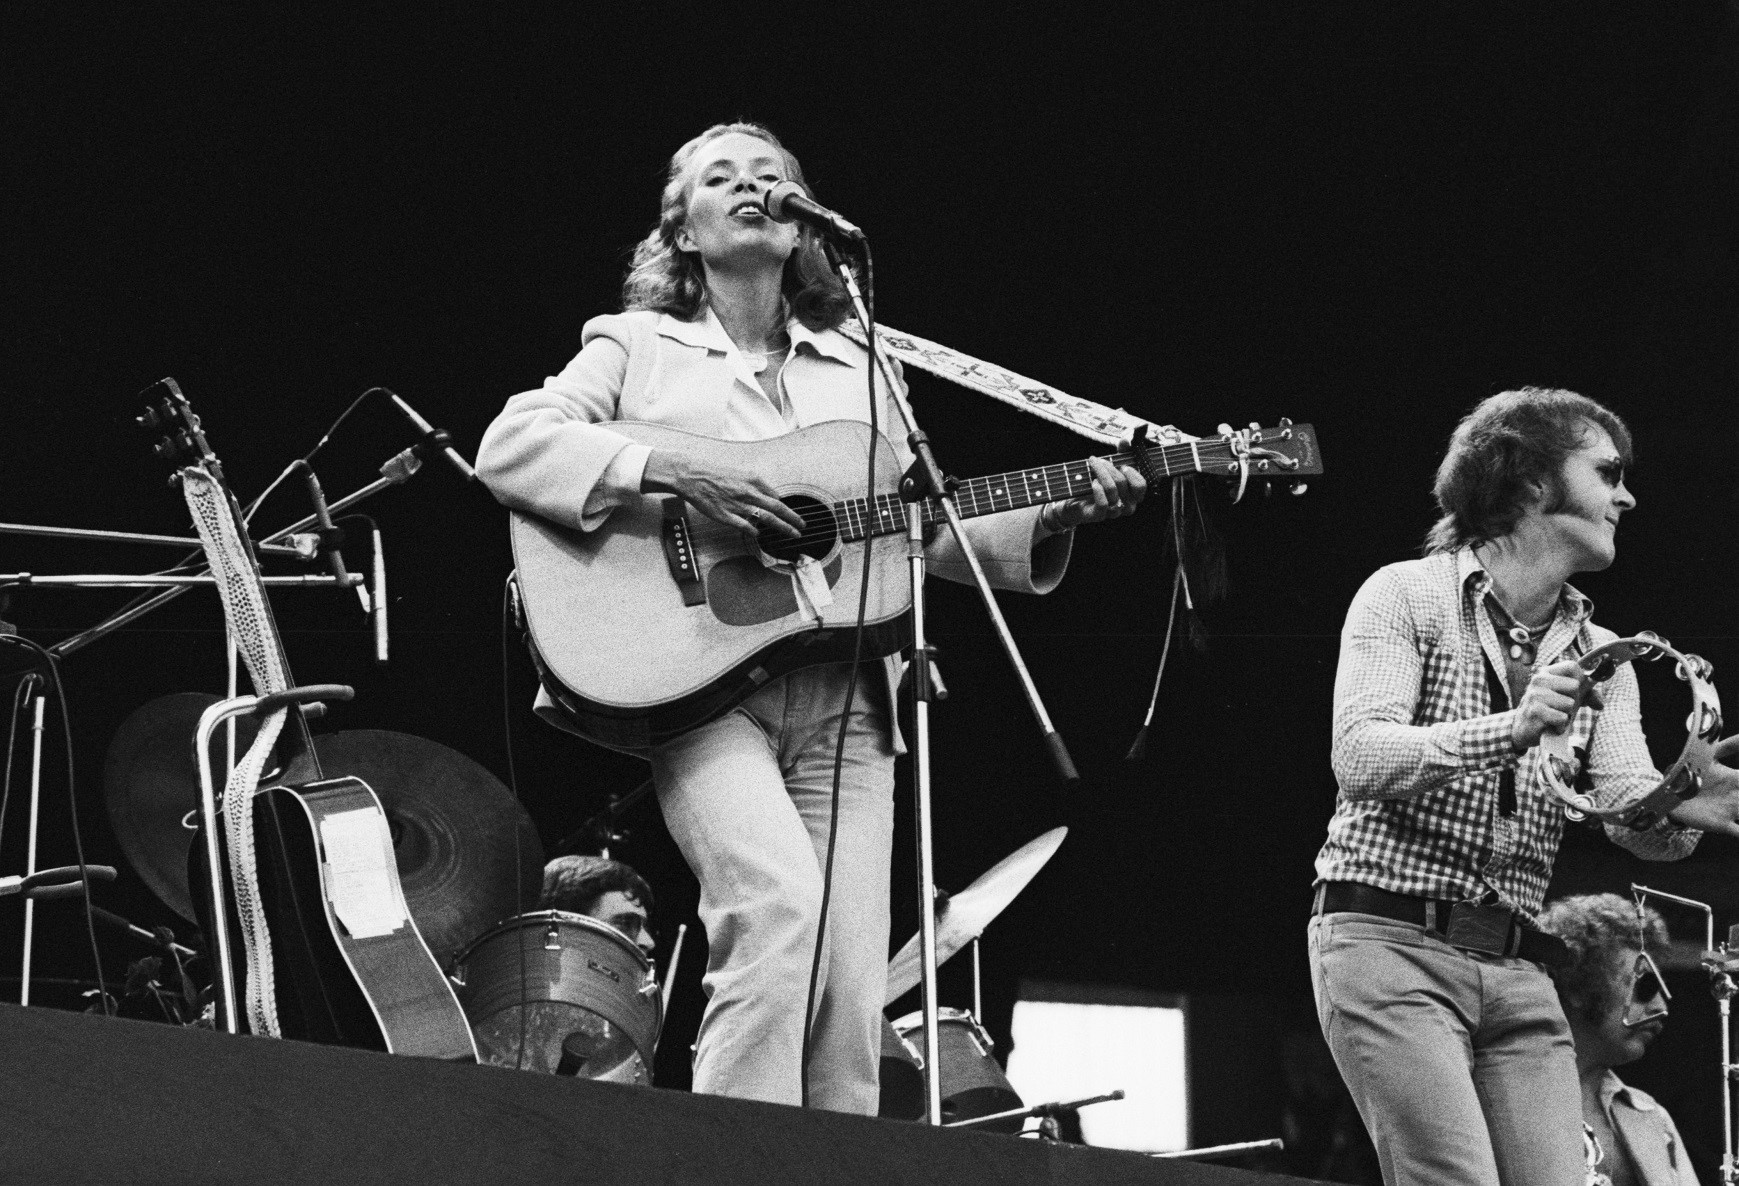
[{"left": 1539, "top": 630, "right": 1722, "bottom": 823}]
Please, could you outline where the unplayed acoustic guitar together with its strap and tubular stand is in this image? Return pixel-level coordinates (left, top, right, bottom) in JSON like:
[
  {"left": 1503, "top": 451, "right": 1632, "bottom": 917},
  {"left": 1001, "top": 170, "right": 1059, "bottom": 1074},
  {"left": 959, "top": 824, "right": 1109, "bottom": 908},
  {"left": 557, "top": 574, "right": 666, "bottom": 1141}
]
[{"left": 139, "top": 379, "right": 476, "bottom": 1061}]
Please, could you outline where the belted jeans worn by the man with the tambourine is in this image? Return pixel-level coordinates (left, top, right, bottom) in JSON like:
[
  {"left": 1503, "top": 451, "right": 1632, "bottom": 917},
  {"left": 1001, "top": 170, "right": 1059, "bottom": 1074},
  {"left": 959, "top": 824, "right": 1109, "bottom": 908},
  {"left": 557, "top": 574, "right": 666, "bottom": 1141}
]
[{"left": 1309, "top": 913, "right": 1584, "bottom": 1186}]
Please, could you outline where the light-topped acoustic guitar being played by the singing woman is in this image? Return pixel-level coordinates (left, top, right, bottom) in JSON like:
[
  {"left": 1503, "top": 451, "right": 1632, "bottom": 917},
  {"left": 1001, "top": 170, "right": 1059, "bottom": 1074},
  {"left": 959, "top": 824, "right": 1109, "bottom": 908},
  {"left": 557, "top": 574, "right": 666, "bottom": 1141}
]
[{"left": 511, "top": 421, "right": 1322, "bottom": 750}]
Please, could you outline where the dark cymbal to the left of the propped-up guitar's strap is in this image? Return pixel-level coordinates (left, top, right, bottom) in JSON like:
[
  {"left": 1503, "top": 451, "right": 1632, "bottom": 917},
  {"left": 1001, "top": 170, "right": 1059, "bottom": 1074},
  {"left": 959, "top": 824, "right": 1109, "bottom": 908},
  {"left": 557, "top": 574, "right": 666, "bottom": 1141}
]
[{"left": 103, "top": 692, "right": 277, "bottom": 922}]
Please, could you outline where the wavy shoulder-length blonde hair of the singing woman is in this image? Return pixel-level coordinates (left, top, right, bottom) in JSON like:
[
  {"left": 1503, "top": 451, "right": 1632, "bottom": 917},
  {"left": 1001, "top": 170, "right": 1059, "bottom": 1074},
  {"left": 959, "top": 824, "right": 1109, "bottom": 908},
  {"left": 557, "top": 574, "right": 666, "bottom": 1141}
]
[{"left": 623, "top": 123, "right": 852, "bottom": 332}]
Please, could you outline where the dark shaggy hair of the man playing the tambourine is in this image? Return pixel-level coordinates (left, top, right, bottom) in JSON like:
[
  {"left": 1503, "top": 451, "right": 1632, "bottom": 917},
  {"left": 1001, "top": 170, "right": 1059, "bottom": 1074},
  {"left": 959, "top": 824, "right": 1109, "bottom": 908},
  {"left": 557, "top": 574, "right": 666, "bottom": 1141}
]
[{"left": 1424, "top": 388, "right": 1633, "bottom": 555}]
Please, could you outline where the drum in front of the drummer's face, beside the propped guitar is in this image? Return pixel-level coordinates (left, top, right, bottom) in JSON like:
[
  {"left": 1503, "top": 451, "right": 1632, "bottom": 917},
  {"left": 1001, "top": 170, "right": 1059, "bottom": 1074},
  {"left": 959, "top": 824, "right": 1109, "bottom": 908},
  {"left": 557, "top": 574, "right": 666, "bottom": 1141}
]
[{"left": 452, "top": 909, "right": 664, "bottom": 1087}]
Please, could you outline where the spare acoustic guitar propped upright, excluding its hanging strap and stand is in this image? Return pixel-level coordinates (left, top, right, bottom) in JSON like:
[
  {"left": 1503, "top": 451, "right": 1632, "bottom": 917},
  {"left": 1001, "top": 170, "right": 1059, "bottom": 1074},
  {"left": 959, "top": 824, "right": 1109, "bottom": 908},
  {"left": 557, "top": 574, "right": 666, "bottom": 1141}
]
[{"left": 139, "top": 379, "right": 476, "bottom": 1063}]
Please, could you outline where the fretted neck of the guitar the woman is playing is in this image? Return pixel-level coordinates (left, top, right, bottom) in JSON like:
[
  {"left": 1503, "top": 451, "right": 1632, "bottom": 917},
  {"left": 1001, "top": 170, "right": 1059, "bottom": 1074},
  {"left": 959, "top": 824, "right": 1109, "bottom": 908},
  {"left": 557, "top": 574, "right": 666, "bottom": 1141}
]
[{"left": 835, "top": 440, "right": 1235, "bottom": 539}]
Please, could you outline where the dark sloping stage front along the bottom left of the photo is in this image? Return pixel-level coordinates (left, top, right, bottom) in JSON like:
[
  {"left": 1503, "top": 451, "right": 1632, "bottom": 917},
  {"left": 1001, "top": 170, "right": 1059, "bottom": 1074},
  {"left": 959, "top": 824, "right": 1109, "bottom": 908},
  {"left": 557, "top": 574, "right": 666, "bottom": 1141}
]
[{"left": 0, "top": 1005, "right": 1328, "bottom": 1186}]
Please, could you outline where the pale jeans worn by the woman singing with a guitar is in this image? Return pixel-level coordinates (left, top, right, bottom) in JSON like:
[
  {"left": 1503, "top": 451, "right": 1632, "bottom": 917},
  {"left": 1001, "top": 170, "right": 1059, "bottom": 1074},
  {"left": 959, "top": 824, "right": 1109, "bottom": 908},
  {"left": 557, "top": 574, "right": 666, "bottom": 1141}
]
[{"left": 652, "top": 663, "right": 894, "bottom": 1116}]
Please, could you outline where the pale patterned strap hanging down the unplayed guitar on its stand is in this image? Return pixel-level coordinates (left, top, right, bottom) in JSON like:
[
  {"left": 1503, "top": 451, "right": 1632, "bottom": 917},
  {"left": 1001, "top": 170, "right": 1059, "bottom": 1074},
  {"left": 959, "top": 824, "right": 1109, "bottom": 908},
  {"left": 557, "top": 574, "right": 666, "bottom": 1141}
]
[{"left": 181, "top": 466, "right": 289, "bottom": 1038}]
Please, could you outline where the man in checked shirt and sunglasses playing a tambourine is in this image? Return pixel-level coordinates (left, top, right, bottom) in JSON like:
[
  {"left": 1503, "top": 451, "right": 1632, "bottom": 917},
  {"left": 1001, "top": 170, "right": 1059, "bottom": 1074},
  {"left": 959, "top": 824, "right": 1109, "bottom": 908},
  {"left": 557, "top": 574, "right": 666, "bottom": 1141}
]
[{"left": 1309, "top": 388, "right": 1739, "bottom": 1186}]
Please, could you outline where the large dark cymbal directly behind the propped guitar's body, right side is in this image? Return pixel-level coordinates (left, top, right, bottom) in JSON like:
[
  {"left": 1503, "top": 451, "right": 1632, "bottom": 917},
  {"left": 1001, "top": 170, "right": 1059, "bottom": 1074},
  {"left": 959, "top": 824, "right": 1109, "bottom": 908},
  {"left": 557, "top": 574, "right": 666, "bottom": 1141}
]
[{"left": 315, "top": 729, "right": 544, "bottom": 969}]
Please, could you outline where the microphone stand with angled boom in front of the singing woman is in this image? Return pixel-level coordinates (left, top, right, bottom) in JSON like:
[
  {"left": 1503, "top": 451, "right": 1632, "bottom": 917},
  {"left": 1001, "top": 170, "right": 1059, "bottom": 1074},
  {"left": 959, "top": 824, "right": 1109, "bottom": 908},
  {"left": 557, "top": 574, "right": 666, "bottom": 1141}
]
[{"left": 821, "top": 235, "right": 1080, "bottom": 1125}]
